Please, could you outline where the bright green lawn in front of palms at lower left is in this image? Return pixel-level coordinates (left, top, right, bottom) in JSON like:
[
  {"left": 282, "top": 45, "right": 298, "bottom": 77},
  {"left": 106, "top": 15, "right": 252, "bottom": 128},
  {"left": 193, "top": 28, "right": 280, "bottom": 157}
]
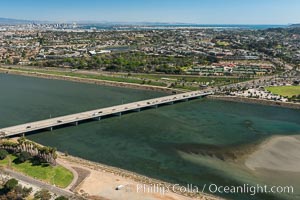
[{"left": 0, "top": 155, "right": 73, "bottom": 188}]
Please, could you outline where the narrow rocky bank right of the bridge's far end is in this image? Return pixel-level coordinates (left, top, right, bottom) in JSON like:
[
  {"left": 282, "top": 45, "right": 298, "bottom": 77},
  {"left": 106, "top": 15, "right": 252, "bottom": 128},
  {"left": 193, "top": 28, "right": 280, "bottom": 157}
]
[{"left": 207, "top": 95, "right": 300, "bottom": 109}]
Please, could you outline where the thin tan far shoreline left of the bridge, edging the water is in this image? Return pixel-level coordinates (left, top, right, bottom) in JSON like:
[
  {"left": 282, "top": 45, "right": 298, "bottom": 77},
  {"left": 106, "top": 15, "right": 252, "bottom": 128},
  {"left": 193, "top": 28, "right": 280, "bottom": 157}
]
[{"left": 0, "top": 66, "right": 185, "bottom": 94}]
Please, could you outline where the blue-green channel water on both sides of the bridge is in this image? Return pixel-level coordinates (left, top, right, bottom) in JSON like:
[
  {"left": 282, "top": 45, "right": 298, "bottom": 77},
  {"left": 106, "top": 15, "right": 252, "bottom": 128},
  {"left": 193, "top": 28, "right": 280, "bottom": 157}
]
[{"left": 0, "top": 74, "right": 300, "bottom": 200}]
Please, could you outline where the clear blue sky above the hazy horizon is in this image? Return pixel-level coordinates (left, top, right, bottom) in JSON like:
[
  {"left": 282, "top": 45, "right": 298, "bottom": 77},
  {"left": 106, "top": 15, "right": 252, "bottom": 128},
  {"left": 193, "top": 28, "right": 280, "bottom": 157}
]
[{"left": 0, "top": 0, "right": 300, "bottom": 24}]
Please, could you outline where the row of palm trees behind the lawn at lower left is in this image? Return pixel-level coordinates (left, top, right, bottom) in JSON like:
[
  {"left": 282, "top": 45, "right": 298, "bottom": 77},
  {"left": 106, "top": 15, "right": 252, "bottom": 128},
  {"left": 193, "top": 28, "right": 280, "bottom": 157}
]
[{"left": 0, "top": 137, "right": 57, "bottom": 165}]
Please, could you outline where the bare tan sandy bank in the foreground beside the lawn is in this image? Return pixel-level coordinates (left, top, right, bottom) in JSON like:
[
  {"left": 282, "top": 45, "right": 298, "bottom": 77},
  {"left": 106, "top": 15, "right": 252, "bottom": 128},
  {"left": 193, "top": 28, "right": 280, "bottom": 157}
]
[{"left": 58, "top": 153, "right": 221, "bottom": 200}]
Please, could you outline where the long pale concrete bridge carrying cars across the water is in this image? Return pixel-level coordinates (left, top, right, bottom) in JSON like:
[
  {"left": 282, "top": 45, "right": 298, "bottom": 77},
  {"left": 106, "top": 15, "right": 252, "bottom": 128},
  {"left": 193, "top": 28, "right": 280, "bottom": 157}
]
[{"left": 0, "top": 91, "right": 212, "bottom": 138}]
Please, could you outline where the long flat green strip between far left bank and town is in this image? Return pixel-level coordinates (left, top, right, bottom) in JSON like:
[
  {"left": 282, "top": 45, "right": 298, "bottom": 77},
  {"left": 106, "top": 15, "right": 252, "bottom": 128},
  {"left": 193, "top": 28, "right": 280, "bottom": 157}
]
[{"left": 4, "top": 68, "right": 251, "bottom": 90}]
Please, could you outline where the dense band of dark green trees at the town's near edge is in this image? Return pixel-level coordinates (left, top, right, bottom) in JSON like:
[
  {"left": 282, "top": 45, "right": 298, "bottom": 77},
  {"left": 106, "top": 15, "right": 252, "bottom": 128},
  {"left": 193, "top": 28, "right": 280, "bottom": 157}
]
[{"left": 33, "top": 52, "right": 211, "bottom": 74}]
